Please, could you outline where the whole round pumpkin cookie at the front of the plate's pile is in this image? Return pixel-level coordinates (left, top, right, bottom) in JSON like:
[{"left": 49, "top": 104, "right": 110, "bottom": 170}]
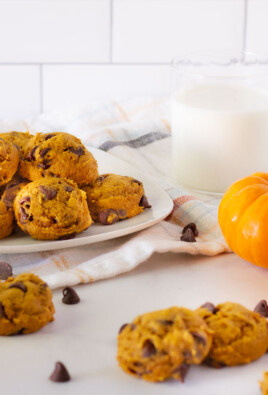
[{"left": 14, "top": 177, "right": 92, "bottom": 240}]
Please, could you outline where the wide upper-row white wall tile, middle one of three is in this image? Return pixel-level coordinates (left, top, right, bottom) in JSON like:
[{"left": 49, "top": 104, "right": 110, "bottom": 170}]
[{"left": 113, "top": 0, "right": 245, "bottom": 63}]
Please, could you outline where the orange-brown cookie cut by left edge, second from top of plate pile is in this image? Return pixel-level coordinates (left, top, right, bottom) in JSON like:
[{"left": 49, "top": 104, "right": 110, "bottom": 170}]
[{"left": 0, "top": 138, "right": 19, "bottom": 185}]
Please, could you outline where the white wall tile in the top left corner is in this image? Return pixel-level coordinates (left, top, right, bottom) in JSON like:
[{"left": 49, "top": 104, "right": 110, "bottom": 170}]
[{"left": 0, "top": 0, "right": 110, "bottom": 63}]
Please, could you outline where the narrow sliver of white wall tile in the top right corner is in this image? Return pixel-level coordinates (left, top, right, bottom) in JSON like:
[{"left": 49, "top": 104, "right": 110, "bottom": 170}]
[{"left": 246, "top": 0, "right": 268, "bottom": 55}]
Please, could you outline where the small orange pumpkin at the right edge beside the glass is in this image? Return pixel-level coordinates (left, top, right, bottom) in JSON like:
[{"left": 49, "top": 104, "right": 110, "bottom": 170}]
[{"left": 218, "top": 173, "right": 268, "bottom": 268}]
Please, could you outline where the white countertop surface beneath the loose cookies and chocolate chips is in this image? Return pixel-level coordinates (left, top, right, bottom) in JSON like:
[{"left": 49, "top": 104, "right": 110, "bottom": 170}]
[{"left": 0, "top": 253, "right": 268, "bottom": 395}]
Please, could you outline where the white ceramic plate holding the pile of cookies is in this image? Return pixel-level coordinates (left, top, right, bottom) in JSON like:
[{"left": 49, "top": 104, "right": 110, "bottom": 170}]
[{"left": 0, "top": 148, "right": 173, "bottom": 254}]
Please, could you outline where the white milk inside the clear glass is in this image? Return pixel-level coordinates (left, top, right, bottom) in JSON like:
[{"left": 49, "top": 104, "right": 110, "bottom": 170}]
[{"left": 171, "top": 84, "right": 268, "bottom": 193}]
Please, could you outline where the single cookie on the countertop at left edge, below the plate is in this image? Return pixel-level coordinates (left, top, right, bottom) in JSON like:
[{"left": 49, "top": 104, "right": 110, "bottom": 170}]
[{"left": 0, "top": 273, "right": 55, "bottom": 335}]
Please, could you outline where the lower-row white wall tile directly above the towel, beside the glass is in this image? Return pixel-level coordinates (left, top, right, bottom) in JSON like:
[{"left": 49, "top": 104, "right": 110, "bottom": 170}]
[{"left": 43, "top": 65, "right": 170, "bottom": 112}]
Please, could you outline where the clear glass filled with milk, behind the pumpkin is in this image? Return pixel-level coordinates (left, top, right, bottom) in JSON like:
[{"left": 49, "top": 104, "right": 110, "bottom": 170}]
[{"left": 171, "top": 51, "right": 268, "bottom": 194}]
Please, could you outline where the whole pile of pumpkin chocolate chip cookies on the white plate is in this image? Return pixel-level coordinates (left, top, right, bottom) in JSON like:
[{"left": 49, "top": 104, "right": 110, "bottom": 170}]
[{"left": 0, "top": 132, "right": 150, "bottom": 240}]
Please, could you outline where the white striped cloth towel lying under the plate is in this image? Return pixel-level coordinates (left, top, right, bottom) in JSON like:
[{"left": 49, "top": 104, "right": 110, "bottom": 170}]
[{"left": 0, "top": 99, "right": 229, "bottom": 288}]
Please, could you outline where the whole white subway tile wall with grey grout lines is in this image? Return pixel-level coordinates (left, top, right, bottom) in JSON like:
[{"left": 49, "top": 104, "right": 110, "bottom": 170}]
[{"left": 0, "top": 0, "right": 268, "bottom": 118}]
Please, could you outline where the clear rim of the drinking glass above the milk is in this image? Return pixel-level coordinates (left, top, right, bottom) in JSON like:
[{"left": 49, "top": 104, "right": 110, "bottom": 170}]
[{"left": 170, "top": 49, "right": 268, "bottom": 80}]
